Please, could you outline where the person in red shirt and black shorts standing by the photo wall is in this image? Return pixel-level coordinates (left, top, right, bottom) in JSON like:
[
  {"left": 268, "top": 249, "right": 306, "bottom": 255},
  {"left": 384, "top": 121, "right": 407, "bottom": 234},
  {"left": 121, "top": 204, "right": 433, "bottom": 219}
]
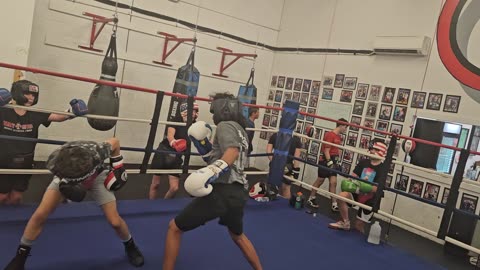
[{"left": 307, "top": 118, "right": 348, "bottom": 212}]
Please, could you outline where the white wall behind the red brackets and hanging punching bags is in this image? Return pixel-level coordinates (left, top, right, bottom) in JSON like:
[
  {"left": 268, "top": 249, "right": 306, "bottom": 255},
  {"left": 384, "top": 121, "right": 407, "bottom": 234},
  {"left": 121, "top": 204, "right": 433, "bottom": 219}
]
[{"left": 17, "top": 0, "right": 283, "bottom": 164}]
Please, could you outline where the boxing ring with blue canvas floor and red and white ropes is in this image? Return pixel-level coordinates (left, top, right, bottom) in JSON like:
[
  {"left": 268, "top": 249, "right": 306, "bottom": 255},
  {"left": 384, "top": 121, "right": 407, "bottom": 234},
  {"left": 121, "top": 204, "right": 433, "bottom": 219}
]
[{"left": 0, "top": 63, "right": 480, "bottom": 270}]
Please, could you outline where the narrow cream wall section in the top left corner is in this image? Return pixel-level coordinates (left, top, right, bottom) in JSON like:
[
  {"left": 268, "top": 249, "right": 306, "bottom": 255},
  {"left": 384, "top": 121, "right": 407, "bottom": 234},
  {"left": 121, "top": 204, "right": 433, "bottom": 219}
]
[{"left": 0, "top": 0, "right": 35, "bottom": 86}]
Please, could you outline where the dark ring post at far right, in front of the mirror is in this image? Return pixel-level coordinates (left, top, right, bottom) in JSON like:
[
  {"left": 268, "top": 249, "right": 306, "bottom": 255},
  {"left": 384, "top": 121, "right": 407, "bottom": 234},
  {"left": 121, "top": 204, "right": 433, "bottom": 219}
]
[{"left": 437, "top": 149, "right": 470, "bottom": 240}]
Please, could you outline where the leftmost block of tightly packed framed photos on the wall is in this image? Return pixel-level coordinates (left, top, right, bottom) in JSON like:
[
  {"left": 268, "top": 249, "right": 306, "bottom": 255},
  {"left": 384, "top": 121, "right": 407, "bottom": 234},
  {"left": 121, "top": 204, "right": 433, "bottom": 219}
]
[{"left": 260, "top": 75, "right": 323, "bottom": 163}]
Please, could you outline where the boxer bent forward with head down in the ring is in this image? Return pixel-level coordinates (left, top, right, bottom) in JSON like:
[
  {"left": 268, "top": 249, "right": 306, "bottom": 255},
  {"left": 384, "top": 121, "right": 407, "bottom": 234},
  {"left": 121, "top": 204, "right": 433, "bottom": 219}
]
[{"left": 5, "top": 138, "right": 144, "bottom": 270}]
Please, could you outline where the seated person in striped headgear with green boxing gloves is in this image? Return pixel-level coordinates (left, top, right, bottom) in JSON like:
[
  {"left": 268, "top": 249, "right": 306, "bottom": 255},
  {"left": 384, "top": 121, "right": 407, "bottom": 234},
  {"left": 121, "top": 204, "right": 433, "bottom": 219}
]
[{"left": 328, "top": 138, "right": 387, "bottom": 233}]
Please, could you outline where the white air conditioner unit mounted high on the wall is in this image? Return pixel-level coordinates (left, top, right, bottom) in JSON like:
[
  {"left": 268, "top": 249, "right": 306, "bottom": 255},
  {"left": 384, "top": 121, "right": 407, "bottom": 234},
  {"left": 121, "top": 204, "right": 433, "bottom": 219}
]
[{"left": 373, "top": 36, "right": 432, "bottom": 56}]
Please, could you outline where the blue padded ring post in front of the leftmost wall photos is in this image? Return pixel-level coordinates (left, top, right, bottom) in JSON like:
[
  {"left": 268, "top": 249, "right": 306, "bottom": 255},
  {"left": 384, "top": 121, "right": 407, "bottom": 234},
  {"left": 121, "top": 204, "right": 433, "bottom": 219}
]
[{"left": 268, "top": 100, "right": 300, "bottom": 187}]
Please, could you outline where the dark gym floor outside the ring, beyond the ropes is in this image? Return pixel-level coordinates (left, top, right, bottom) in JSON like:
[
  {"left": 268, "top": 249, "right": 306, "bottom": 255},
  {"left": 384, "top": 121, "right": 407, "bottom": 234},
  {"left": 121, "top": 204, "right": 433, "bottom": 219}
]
[{"left": 6, "top": 165, "right": 475, "bottom": 270}]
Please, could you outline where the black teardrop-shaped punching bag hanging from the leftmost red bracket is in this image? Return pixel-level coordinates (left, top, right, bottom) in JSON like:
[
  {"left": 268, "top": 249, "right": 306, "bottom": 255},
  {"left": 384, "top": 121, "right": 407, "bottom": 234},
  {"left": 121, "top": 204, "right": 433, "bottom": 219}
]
[{"left": 88, "top": 33, "right": 120, "bottom": 131}]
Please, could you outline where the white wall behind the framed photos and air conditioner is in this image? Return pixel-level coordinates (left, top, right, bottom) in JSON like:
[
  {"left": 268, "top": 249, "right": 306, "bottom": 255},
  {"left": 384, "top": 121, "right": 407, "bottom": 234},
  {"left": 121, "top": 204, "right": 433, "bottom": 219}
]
[{"left": 260, "top": 0, "right": 480, "bottom": 245}]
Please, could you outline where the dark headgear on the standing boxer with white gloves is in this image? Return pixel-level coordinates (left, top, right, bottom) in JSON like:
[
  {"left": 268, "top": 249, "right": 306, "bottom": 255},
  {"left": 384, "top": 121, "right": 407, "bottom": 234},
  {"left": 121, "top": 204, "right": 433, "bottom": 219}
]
[{"left": 210, "top": 97, "right": 246, "bottom": 127}]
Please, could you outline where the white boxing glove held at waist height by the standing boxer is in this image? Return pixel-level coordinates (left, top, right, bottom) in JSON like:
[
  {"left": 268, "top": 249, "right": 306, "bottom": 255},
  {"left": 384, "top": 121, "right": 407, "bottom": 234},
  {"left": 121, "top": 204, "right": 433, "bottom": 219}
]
[{"left": 184, "top": 159, "right": 229, "bottom": 197}]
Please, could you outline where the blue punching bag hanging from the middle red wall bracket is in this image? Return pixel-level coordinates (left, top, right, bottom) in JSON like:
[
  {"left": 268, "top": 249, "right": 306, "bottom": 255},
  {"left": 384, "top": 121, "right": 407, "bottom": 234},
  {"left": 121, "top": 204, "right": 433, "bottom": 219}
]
[{"left": 165, "top": 47, "right": 200, "bottom": 122}]
